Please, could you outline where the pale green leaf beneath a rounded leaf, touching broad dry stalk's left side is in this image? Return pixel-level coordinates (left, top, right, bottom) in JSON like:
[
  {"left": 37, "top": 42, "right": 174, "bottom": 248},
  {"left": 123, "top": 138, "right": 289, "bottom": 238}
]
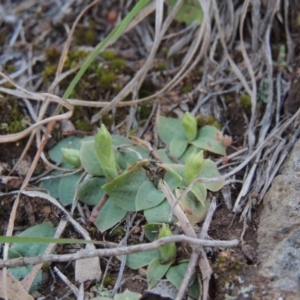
[{"left": 144, "top": 200, "right": 174, "bottom": 224}]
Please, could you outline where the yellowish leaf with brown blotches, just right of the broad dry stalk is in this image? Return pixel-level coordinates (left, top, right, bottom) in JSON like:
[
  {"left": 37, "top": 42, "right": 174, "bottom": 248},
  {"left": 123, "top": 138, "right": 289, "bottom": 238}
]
[{"left": 176, "top": 190, "right": 209, "bottom": 225}]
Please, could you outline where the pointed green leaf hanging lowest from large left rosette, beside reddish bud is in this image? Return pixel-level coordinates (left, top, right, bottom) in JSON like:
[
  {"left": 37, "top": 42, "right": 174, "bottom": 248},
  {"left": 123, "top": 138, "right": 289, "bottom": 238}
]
[{"left": 94, "top": 199, "right": 126, "bottom": 232}]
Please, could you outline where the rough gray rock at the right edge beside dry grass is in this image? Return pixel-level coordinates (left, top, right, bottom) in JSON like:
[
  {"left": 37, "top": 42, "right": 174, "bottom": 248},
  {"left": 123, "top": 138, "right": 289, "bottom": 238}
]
[{"left": 257, "top": 140, "right": 300, "bottom": 299}]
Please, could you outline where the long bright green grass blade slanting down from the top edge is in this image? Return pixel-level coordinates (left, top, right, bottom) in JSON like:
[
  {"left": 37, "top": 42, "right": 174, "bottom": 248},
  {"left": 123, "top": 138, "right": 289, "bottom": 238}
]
[{"left": 63, "top": 0, "right": 151, "bottom": 99}]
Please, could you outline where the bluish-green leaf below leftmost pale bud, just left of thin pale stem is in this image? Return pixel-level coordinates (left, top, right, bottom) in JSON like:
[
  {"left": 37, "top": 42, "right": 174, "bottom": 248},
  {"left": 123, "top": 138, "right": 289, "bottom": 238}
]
[{"left": 58, "top": 173, "right": 82, "bottom": 205}]
